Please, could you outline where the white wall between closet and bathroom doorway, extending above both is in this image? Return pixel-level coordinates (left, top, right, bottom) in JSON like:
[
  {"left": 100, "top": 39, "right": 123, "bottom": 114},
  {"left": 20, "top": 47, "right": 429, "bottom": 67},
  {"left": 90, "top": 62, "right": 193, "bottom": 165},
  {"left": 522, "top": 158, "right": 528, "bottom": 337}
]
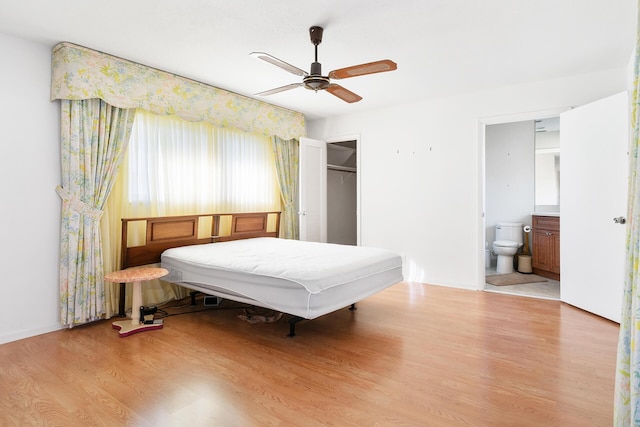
[{"left": 307, "top": 67, "right": 627, "bottom": 289}]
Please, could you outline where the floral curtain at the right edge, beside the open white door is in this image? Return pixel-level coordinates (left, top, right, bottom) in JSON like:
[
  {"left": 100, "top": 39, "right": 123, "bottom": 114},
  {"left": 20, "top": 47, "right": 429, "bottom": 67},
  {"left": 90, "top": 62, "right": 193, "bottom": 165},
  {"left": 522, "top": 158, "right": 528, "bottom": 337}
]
[{"left": 614, "top": 3, "right": 640, "bottom": 426}]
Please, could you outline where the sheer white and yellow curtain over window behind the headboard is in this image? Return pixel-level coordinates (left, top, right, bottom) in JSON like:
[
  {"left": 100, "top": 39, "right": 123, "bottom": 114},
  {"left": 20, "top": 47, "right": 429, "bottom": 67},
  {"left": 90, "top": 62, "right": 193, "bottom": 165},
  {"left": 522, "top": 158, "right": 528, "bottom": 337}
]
[{"left": 103, "top": 110, "right": 281, "bottom": 314}]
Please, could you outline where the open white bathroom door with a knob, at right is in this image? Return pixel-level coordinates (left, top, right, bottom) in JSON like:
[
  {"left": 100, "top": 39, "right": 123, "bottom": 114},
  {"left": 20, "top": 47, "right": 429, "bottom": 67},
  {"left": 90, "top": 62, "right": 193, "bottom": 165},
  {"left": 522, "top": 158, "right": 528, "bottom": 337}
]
[{"left": 560, "top": 92, "right": 629, "bottom": 323}]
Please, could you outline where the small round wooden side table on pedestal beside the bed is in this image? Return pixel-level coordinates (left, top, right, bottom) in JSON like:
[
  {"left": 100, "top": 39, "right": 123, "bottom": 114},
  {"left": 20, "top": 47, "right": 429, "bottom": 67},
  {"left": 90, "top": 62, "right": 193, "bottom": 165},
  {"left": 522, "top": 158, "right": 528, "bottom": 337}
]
[{"left": 104, "top": 267, "right": 169, "bottom": 337}]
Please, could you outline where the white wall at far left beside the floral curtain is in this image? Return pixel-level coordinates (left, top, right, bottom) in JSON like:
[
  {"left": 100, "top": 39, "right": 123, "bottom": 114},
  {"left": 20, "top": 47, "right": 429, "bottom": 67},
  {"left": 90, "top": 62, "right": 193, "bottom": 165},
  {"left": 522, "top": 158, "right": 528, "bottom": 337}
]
[{"left": 0, "top": 34, "right": 61, "bottom": 343}]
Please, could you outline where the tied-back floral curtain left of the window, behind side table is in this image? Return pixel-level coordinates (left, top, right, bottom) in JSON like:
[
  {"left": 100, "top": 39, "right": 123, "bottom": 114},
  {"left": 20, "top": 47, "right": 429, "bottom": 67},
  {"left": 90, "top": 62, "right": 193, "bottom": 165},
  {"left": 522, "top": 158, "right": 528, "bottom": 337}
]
[{"left": 56, "top": 99, "right": 135, "bottom": 327}]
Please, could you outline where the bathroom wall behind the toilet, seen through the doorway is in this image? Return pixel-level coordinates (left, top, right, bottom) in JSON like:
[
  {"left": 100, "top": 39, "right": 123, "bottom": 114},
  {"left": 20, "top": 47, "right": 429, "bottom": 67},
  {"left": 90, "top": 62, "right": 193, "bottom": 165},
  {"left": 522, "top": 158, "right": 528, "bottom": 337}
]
[{"left": 485, "top": 120, "right": 535, "bottom": 266}]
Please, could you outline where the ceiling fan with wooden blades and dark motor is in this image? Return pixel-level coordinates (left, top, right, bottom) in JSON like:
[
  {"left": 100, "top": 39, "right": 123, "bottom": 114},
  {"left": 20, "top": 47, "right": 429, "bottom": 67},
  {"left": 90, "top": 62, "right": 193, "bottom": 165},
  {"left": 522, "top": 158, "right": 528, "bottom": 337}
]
[{"left": 250, "top": 26, "right": 398, "bottom": 103}]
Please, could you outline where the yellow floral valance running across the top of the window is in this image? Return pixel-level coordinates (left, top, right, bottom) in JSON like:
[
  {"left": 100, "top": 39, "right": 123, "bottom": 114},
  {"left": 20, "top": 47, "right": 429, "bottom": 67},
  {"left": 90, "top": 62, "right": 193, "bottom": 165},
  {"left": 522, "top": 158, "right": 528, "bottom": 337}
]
[{"left": 51, "top": 42, "right": 305, "bottom": 140}]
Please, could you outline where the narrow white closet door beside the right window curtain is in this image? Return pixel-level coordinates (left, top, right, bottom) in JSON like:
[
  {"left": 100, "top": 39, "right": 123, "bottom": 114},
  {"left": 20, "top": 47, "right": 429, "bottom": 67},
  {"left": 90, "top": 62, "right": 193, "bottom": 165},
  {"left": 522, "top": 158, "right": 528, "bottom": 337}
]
[{"left": 298, "top": 138, "right": 327, "bottom": 242}]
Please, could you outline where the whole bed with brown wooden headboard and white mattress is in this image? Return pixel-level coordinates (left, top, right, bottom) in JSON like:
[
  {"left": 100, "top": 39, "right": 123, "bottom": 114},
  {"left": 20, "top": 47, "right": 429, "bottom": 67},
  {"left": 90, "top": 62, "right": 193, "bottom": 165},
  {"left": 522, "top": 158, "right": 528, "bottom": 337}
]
[{"left": 117, "top": 212, "right": 403, "bottom": 336}]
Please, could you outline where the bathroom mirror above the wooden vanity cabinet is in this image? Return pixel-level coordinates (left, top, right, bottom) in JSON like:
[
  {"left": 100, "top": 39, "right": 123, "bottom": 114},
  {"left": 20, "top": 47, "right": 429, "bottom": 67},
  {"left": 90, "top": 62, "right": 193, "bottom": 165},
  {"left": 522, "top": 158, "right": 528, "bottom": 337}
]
[{"left": 535, "top": 117, "right": 560, "bottom": 212}]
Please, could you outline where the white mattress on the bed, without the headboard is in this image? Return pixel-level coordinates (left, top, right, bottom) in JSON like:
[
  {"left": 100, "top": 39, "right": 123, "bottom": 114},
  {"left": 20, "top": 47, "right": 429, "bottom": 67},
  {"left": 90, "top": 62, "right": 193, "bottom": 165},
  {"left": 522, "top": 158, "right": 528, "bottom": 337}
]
[{"left": 162, "top": 237, "right": 403, "bottom": 319}]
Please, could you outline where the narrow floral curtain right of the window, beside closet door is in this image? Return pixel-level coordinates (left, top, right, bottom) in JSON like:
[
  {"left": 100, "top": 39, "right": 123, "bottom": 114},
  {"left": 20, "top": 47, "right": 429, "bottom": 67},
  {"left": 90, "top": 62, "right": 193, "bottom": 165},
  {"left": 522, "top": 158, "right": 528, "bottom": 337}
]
[{"left": 272, "top": 136, "right": 300, "bottom": 240}]
